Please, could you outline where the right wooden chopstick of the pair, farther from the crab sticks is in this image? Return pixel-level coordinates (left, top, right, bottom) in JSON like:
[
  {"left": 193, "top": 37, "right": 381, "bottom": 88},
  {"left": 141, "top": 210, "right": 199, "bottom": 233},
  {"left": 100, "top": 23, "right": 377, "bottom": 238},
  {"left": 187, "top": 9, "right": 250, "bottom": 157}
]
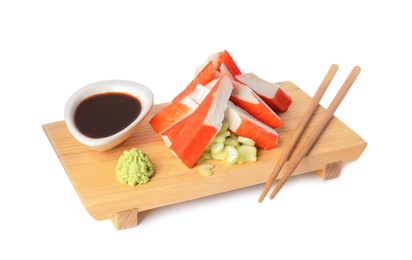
[{"left": 270, "top": 66, "right": 361, "bottom": 199}]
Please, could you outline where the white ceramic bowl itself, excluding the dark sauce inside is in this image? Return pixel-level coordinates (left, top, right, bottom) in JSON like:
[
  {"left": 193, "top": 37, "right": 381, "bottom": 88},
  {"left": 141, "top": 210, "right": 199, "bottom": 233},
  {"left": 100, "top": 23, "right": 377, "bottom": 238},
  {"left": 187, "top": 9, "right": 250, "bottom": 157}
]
[{"left": 64, "top": 80, "right": 153, "bottom": 151}]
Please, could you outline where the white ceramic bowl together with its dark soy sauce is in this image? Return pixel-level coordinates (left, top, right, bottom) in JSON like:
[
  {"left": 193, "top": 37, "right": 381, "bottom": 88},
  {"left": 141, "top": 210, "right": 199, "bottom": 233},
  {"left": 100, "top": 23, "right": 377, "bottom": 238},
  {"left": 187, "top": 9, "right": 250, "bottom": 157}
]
[{"left": 64, "top": 80, "right": 153, "bottom": 151}]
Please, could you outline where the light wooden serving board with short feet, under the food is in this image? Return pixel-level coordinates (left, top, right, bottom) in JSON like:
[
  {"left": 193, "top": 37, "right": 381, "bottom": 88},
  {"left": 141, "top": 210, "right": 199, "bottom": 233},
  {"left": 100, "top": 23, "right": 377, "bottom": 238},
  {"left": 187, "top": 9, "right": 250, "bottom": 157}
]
[{"left": 43, "top": 81, "right": 367, "bottom": 229}]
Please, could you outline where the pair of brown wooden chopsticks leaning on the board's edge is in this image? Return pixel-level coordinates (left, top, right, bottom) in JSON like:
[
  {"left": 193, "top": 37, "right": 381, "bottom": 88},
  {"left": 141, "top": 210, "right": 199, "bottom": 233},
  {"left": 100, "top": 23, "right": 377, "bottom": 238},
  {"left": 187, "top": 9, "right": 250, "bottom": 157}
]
[{"left": 259, "top": 64, "right": 361, "bottom": 202}]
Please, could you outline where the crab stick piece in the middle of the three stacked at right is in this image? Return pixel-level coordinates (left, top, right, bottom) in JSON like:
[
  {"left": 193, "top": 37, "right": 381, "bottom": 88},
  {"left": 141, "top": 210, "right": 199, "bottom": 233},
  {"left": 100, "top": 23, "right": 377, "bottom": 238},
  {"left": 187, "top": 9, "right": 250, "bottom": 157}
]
[{"left": 230, "top": 81, "right": 283, "bottom": 128}]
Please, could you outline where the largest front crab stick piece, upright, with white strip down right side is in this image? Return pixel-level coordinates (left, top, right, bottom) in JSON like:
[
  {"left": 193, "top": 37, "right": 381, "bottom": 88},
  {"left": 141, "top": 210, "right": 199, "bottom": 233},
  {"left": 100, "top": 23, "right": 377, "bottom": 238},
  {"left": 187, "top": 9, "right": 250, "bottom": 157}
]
[{"left": 162, "top": 75, "right": 233, "bottom": 168}]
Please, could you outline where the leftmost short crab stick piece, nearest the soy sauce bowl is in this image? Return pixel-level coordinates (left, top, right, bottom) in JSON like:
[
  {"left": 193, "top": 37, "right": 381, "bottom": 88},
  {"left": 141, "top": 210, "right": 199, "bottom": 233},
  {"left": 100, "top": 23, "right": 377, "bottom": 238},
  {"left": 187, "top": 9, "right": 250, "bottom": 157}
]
[{"left": 149, "top": 96, "right": 198, "bottom": 134}]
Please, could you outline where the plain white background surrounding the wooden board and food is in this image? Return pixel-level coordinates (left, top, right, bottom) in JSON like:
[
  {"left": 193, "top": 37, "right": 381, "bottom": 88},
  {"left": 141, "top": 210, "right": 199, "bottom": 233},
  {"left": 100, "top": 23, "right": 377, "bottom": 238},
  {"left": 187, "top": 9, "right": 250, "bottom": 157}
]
[{"left": 0, "top": 0, "right": 412, "bottom": 259}]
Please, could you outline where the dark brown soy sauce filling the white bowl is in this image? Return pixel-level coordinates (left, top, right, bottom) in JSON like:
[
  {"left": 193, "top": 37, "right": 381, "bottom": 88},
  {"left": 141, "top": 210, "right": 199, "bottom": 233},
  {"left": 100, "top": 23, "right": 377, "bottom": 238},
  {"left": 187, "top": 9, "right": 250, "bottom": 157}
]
[{"left": 74, "top": 92, "right": 142, "bottom": 138}]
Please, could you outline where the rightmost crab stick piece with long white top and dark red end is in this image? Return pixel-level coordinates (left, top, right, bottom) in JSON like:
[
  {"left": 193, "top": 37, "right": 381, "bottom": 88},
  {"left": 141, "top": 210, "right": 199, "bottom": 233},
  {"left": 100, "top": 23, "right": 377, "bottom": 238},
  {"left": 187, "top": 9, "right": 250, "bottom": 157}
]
[{"left": 235, "top": 72, "right": 292, "bottom": 112}]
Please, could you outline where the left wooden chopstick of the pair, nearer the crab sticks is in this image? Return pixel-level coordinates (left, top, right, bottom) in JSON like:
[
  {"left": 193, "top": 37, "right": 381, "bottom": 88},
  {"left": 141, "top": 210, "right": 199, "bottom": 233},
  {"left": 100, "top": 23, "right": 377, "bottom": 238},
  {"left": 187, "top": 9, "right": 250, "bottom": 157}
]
[{"left": 259, "top": 64, "right": 338, "bottom": 202}]
